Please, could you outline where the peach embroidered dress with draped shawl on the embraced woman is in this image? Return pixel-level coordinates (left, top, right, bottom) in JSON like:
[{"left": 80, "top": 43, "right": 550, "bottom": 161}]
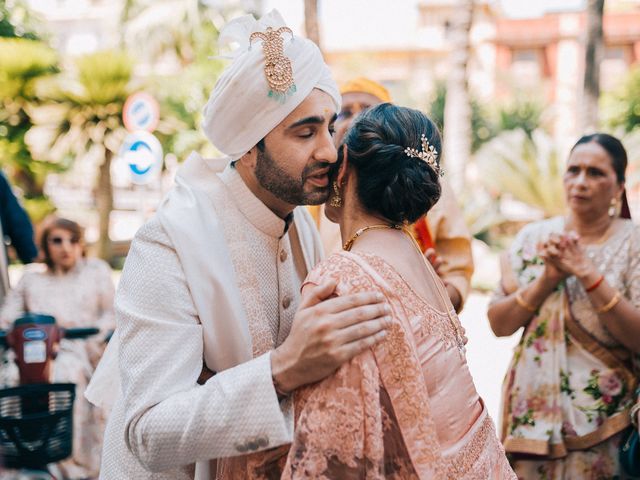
[{"left": 224, "top": 252, "right": 516, "bottom": 480}]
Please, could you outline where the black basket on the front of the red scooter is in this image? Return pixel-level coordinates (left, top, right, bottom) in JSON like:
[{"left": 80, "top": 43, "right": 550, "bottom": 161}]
[{"left": 0, "top": 383, "right": 76, "bottom": 468}]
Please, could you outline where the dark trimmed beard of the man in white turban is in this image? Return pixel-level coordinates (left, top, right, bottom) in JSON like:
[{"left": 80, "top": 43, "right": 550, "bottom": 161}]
[{"left": 255, "top": 148, "right": 331, "bottom": 205}]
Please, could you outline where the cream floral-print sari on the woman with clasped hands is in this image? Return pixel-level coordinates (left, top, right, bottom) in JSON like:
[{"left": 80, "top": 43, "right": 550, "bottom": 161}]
[{"left": 499, "top": 218, "right": 640, "bottom": 480}]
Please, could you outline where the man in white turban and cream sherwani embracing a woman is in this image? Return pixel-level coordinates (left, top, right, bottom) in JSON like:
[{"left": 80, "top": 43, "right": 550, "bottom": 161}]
[{"left": 88, "top": 12, "right": 389, "bottom": 480}]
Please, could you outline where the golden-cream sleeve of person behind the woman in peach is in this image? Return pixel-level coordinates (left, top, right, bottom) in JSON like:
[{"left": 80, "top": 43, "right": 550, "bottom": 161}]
[{"left": 427, "top": 181, "right": 473, "bottom": 303}]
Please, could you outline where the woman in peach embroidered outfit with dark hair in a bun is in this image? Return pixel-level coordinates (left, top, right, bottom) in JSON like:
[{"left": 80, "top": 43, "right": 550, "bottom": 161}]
[{"left": 224, "top": 104, "right": 516, "bottom": 480}]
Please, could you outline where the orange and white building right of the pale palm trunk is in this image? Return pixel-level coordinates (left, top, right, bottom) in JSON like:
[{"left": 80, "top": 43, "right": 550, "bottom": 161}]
[{"left": 494, "top": 7, "right": 640, "bottom": 148}]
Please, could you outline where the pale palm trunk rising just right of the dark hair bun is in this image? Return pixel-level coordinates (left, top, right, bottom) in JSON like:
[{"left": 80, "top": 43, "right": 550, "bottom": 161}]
[{"left": 443, "top": 0, "right": 474, "bottom": 192}]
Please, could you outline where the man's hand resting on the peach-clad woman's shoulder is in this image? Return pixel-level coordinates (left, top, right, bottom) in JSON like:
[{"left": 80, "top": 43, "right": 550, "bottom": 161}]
[{"left": 271, "top": 282, "right": 391, "bottom": 393}]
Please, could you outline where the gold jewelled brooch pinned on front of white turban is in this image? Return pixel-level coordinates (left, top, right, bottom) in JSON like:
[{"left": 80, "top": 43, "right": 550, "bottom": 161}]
[{"left": 249, "top": 27, "right": 296, "bottom": 103}]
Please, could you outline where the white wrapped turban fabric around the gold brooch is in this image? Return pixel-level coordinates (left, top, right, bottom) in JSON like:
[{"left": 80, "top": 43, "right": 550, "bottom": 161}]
[{"left": 202, "top": 10, "right": 340, "bottom": 160}]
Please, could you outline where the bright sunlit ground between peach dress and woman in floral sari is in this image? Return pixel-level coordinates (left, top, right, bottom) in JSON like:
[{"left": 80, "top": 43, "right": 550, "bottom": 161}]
[{"left": 460, "top": 292, "right": 520, "bottom": 423}]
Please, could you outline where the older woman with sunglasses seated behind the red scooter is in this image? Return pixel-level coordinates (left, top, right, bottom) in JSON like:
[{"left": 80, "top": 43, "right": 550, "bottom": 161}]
[{"left": 0, "top": 218, "right": 115, "bottom": 479}]
